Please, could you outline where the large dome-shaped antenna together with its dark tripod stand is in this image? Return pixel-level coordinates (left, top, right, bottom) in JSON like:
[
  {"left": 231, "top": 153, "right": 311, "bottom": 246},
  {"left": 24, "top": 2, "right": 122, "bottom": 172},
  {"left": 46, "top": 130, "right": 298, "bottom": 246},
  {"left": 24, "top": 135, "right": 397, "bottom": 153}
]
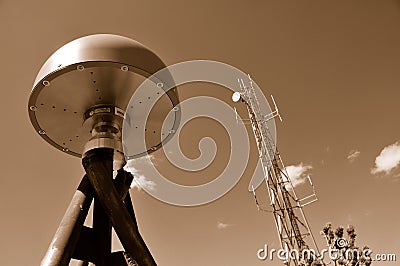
[{"left": 28, "top": 34, "right": 172, "bottom": 266}]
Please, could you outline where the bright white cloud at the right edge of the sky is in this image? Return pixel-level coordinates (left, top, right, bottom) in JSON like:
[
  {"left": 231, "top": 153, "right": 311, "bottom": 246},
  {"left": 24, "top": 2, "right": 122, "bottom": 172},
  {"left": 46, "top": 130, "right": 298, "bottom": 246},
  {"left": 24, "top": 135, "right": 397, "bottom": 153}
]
[{"left": 371, "top": 142, "right": 400, "bottom": 174}]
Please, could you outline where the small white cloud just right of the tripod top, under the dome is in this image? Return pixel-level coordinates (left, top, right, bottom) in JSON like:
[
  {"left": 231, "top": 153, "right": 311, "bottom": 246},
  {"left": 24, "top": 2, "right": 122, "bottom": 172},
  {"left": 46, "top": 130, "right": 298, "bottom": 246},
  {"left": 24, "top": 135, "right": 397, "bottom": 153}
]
[{"left": 124, "top": 155, "right": 156, "bottom": 190}]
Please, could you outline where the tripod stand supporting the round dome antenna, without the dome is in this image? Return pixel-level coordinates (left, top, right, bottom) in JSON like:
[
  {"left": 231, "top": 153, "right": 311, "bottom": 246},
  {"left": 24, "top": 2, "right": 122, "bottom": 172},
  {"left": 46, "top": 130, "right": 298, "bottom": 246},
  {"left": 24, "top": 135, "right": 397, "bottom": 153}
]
[{"left": 41, "top": 148, "right": 156, "bottom": 266}]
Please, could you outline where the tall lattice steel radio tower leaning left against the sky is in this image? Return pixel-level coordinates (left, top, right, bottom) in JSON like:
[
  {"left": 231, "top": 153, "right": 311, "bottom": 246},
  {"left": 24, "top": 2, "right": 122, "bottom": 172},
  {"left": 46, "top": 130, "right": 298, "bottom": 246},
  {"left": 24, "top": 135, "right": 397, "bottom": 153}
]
[{"left": 238, "top": 76, "right": 319, "bottom": 266}]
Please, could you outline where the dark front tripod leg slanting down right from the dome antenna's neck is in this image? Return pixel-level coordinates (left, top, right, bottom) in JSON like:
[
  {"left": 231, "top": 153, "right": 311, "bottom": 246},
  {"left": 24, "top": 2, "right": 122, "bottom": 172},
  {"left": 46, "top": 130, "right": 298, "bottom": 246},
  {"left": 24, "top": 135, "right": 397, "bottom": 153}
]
[{"left": 82, "top": 148, "right": 156, "bottom": 266}]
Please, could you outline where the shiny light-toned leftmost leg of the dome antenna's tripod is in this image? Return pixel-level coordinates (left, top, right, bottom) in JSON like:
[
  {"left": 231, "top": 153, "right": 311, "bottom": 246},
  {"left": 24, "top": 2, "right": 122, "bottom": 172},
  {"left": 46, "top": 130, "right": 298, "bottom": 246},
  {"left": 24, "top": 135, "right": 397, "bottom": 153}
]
[{"left": 41, "top": 175, "right": 93, "bottom": 266}]
